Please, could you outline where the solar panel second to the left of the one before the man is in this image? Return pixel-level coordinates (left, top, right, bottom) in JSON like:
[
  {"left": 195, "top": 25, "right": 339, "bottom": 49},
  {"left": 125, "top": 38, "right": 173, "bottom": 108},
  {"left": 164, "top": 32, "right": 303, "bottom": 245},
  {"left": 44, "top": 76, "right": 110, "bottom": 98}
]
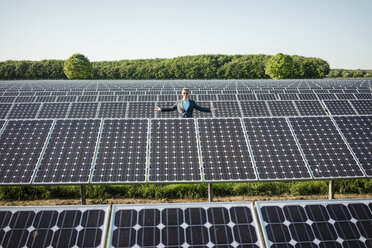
[{"left": 34, "top": 120, "right": 101, "bottom": 183}]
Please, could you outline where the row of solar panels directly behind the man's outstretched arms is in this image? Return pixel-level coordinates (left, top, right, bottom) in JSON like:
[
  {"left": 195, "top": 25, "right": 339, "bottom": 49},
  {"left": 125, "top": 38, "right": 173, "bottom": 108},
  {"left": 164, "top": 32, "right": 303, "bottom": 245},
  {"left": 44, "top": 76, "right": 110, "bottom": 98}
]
[{"left": 0, "top": 100, "right": 372, "bottom": 119}]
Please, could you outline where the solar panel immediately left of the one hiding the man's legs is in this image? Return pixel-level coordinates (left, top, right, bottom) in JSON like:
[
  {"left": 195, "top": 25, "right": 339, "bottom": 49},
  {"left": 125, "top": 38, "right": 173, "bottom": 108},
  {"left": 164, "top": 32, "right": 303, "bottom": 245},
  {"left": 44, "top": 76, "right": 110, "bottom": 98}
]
[{"left": 91, "top": 119, "right": 149, "bottom": 183}]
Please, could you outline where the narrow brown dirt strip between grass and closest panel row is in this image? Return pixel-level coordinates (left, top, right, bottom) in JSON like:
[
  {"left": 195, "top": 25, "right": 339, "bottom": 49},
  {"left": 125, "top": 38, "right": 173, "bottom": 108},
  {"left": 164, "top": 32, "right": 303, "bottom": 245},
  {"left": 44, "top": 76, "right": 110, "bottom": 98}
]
[{"left": 0, "top": 194, "right": 372, "bottom": 206}]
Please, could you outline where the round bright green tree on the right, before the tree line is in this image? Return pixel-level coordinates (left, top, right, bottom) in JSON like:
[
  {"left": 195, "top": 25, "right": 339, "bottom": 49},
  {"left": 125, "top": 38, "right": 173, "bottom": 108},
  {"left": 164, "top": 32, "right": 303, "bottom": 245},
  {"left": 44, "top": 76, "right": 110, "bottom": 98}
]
[{"left": 265, "top": 53, "right": 293, "bottom": 79}]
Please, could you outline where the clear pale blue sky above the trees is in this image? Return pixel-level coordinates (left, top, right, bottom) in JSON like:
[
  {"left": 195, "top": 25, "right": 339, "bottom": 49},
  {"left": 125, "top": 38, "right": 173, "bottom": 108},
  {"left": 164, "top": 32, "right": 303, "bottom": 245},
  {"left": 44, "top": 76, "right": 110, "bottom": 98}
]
[{"left": 0, "top": 0, "right": 372, "bottom": 69}]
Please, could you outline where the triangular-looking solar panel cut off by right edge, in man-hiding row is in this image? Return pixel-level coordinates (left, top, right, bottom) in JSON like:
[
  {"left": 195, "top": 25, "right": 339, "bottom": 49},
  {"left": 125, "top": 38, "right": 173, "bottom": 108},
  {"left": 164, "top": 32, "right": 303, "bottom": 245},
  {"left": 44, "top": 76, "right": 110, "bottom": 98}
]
[{"left": 334, "top": 116, "right": 372, "bottom": 176}]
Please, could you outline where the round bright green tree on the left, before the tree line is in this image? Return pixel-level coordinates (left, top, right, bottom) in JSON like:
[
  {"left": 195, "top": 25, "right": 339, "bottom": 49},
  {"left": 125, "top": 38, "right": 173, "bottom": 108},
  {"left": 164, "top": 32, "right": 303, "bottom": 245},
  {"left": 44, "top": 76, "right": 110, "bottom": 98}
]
[{"left": 63, "top": 53, "right": 92, "bottom": 79}]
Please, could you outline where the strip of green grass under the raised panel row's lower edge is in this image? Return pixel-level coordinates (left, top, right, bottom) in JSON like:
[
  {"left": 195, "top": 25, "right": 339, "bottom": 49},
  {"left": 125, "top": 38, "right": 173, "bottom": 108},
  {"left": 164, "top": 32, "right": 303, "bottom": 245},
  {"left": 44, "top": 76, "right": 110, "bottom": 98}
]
[{"left": 0, "top": 179, "right": 372, "bottom": 201}]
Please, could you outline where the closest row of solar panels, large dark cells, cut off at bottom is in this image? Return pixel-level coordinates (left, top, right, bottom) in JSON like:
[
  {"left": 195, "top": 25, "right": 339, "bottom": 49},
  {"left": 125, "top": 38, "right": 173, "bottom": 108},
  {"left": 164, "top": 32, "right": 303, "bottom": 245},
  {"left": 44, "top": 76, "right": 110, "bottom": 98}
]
[{"left": 0, "top": 199, "right": 372, "bottom": 248}]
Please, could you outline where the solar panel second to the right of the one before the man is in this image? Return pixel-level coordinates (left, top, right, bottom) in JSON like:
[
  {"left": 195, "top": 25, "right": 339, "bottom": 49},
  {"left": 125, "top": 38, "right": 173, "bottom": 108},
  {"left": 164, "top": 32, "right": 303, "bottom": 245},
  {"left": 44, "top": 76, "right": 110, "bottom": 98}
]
[{"left": 244, "top": 118, "right": 311, "bottom": 180}]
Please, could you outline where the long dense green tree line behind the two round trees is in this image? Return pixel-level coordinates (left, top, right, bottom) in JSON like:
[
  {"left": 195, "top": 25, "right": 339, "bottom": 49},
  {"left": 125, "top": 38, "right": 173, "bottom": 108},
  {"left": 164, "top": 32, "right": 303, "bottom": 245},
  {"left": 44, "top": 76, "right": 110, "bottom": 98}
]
[{"left": 0, "top": 54, "right": 330, "bottom": 80}]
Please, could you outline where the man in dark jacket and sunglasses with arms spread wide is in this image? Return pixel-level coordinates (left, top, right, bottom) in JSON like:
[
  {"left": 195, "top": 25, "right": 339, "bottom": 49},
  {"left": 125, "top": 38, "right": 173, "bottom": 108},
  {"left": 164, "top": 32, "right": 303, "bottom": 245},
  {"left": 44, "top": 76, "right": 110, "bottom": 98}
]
[{"left": 155, "top": 88, "right": 216, "bottom": 118}]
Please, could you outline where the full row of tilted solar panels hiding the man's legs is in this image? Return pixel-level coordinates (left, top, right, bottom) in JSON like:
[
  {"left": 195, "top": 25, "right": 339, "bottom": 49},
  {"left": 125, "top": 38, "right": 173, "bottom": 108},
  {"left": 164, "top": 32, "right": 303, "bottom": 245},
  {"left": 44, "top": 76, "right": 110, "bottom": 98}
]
[{"left": 0, "top": 116, "right": 372, "bottom": 185}]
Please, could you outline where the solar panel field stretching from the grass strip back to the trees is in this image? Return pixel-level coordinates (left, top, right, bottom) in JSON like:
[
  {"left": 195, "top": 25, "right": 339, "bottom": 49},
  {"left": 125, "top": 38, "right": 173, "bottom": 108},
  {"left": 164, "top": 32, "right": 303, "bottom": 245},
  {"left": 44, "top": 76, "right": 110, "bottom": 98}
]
[{"left": 0, "top": 80, "right": 372, "bottom": 184}]
